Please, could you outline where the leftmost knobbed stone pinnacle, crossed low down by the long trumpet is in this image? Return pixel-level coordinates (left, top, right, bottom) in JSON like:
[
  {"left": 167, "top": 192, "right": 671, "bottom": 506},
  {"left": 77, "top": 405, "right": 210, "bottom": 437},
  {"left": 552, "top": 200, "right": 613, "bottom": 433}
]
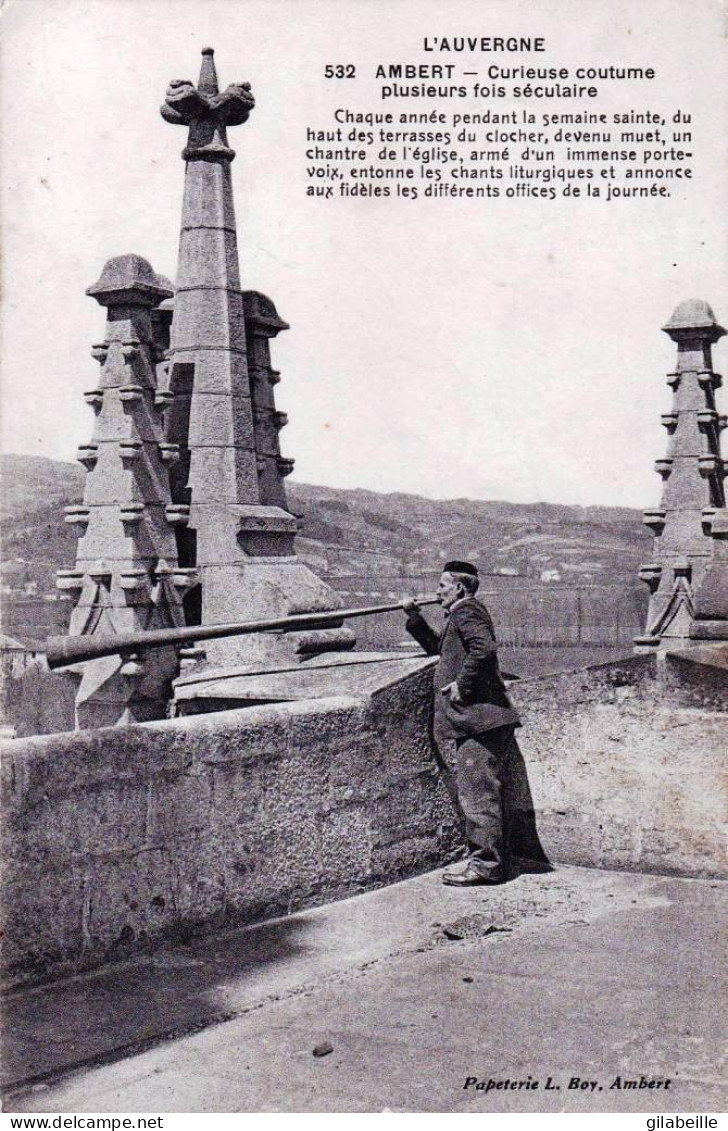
[{"left": 57, "top": 256, "right": 192, "bottom": 727}]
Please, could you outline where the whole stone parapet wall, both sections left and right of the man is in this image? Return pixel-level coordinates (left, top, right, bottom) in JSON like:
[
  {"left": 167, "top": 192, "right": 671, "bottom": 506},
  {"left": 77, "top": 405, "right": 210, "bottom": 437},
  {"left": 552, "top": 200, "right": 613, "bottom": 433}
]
[{"left": 2, "top": 654, "right": 728, "bottom": 981}]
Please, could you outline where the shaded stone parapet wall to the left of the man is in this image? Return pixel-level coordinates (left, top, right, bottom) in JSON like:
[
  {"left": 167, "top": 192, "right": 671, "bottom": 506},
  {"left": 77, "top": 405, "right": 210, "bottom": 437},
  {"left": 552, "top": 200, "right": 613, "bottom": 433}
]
[{"left": 2, "top": 668, "right": 457, "bottom": 979}]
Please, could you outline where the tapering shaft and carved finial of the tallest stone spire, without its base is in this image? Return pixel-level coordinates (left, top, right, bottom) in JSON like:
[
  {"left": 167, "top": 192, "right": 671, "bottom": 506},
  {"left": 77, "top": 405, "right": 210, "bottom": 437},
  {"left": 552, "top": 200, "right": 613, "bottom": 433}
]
[{"left": 162, "top": 48, "right": 260, "bottom": 510}]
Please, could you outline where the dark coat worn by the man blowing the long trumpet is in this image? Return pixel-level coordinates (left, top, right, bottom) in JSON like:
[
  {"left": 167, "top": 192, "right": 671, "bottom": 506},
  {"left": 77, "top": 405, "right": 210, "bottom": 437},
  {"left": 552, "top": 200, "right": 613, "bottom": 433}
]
[{"left": 407, "top": 597, "right": 520, "bottom": 739}]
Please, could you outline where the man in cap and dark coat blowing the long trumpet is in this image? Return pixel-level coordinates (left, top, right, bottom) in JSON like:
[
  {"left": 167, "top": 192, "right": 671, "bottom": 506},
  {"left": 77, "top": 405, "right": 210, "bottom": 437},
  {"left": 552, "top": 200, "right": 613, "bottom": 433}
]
[{"left": 404, "top": 561, "right": 520, "bottom": 888}]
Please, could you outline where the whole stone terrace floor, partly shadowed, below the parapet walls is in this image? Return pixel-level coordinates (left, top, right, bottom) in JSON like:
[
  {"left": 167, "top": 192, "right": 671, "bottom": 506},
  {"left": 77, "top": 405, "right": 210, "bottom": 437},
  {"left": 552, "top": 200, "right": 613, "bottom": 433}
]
[{"left": 3, "top": 867, "right": 728, "bottom": 1114}]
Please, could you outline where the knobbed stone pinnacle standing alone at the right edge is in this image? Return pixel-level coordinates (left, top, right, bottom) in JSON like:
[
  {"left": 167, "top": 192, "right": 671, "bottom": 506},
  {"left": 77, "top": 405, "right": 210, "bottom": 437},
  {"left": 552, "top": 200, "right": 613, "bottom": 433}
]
[{"left": 635, "top": 299, "right": 728, "bottom": 649}]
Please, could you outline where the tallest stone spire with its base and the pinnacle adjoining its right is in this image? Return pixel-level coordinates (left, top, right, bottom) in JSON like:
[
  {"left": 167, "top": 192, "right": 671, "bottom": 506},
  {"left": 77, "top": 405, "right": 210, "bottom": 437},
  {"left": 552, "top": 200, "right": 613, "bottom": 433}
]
[{"left": 162, "top": 48, "right": 355, "bottom": 666}]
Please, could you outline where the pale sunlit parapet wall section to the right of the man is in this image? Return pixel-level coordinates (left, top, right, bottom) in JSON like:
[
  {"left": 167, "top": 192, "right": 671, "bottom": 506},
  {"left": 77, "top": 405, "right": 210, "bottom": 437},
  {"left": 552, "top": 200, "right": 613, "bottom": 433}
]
[{"left": 511, "top": 655, "right": 728, "bottom": 877}]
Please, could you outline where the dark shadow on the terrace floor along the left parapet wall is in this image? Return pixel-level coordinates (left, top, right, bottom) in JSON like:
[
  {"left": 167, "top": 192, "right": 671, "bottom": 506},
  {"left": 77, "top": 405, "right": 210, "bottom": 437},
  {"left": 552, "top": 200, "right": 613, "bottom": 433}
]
[{"left": 0, "top": 917, "right": 316, "bottom": 1089}]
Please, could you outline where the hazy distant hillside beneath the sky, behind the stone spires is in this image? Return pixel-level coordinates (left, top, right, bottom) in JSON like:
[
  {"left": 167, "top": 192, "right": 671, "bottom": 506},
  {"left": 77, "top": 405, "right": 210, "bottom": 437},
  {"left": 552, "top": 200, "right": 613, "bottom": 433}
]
[{"left": 0, "top": 455, "right": 650, "bottom": 636}]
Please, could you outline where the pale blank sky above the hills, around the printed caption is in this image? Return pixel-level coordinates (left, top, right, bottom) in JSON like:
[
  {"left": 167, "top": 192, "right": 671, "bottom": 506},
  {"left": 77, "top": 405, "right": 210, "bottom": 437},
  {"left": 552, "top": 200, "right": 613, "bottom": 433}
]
[{"left": 0, "top": 0, "right": 728, "bottom": 507}]
